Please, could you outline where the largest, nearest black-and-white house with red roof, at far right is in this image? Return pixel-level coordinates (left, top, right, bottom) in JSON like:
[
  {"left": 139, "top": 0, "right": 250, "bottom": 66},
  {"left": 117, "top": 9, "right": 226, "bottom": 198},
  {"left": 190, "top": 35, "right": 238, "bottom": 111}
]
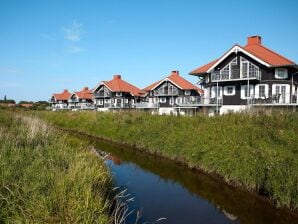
[{"left": 190, "top": 36, "right": 298, "bottom": 114}]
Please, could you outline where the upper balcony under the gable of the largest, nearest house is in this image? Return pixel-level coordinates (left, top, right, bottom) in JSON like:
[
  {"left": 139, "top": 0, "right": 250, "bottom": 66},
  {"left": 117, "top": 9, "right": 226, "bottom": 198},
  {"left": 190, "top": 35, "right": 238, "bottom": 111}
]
[{"left": 211, "top": 69, "right": 261, "bottom": 82}]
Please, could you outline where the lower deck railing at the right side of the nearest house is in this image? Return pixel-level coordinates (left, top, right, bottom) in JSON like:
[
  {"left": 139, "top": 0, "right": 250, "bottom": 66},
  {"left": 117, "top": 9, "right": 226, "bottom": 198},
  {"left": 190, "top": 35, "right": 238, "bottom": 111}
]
[{"left": 250, "top": 93, "right": 298, "bottom": 106}]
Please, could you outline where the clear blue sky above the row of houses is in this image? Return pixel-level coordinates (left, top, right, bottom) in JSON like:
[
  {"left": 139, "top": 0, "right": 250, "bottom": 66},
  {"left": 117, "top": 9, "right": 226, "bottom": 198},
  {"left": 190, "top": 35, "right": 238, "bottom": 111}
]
[{"left": 0, "top": 0, "right": 298, "bottom": 101}]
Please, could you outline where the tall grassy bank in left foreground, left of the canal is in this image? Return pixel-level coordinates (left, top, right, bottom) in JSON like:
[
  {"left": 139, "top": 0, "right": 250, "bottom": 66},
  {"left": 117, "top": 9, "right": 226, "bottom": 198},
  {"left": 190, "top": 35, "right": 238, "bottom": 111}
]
[{"left": 0, "top": 110, "right": 111, "bottom": 224}]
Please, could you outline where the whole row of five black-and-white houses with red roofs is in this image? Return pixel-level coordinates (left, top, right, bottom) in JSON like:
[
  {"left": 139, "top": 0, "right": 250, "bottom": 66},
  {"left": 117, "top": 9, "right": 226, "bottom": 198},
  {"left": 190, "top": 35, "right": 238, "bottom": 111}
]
[{"left": 50, "top": 36, "right": 298, "bottom": 114}]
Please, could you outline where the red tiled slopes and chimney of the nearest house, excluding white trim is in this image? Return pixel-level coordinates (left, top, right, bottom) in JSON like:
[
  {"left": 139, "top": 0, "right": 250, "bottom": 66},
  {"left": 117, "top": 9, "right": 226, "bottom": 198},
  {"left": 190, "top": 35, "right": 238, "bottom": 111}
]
[{"left": 189, "top": 36, "right": 295, "bottom": 75}]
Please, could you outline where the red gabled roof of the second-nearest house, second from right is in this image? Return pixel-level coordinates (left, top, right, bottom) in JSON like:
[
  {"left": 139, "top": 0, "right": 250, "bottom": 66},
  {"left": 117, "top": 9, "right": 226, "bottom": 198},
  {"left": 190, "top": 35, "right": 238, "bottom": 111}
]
[{"left": 143, "top": 71, "right": 204, "bottom": 94}]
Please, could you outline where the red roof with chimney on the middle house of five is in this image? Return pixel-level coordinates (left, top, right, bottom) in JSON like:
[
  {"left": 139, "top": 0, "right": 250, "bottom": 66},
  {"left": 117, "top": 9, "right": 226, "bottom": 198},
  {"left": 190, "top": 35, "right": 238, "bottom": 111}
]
[{"left": 93, "top": 75, "right": 142, "bottom": 96}]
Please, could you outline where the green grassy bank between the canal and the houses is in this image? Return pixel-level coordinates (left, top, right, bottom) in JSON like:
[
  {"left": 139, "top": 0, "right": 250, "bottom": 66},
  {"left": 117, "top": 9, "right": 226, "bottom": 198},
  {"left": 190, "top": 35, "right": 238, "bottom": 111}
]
[{"left": 34, "top": 112, "right": 298, "bottom": 210}]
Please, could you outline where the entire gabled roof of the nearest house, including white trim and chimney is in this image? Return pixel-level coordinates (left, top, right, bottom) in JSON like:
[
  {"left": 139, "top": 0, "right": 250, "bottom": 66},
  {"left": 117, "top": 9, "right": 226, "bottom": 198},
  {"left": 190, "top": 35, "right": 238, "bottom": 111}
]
[{"left": 189, "top": 36, "right": 295, "bottom": 75}]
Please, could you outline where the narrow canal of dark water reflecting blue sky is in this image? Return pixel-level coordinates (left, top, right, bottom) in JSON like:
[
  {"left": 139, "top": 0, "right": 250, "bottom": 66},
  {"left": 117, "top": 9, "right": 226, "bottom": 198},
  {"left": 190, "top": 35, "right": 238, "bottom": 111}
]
[{"left": 73, "top": 134, "right": 298, "bottom": 224}]
